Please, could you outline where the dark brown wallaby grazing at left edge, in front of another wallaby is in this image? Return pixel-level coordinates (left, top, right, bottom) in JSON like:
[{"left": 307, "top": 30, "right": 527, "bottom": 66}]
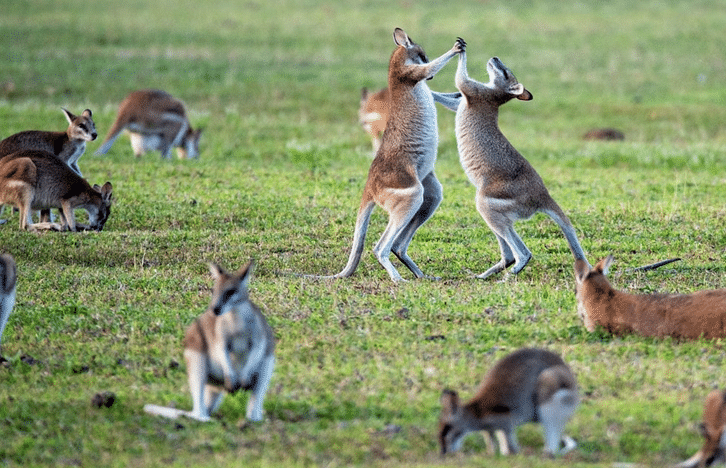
[{"left": 0, "top": 150, "right": 113, "bottom": 231}]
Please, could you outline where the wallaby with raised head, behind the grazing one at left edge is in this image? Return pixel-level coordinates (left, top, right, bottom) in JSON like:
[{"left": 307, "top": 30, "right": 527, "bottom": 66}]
[{"left": 0, "top": 109, "right": 98, "bottom": 176}]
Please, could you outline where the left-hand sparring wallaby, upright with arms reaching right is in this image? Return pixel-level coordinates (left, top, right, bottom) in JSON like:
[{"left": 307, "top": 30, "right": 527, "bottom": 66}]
[{"left": 322, "top": 28, "right": 466, "bottom": 281}]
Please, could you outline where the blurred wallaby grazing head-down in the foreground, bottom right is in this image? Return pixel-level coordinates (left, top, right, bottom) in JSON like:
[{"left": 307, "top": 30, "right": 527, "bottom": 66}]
[{"left": 439, "top": 348, "right": 579, "bottom": 455}]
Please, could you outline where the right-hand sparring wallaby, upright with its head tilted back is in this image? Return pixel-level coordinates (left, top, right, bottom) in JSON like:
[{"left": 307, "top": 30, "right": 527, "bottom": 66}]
[{"left": 455, "top": 52, "right": 586, "bottom": 278}]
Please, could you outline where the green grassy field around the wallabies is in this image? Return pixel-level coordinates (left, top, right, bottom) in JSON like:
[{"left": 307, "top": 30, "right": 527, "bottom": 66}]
[{"left": 0, "top": 0, "right": 726, "bottom": 467}]
